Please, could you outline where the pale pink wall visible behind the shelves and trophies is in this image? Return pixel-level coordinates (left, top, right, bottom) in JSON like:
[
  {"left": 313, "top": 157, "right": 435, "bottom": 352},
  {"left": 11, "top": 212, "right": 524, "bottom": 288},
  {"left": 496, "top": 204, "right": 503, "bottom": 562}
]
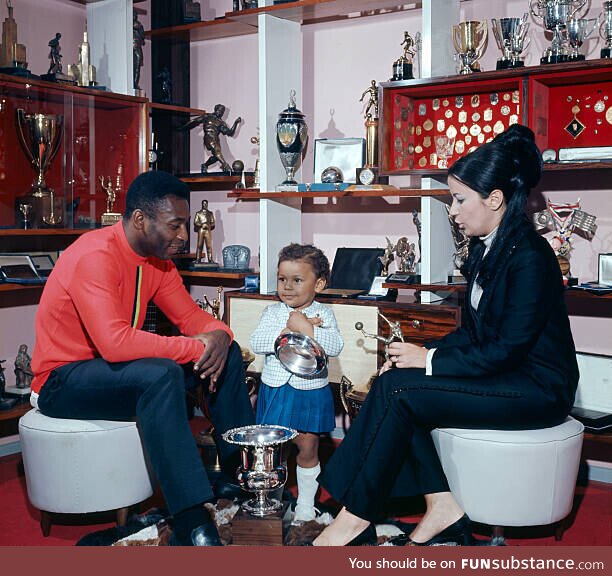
[{"left": 0, "top": 0, "right": 612, "bottom": 383}]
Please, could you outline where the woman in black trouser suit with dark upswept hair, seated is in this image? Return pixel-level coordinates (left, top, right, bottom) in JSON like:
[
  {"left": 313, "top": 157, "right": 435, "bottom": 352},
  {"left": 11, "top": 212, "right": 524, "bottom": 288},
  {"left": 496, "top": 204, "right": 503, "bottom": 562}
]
[{"left": 314, "top": 125, "right": 578, "bottom": 546}]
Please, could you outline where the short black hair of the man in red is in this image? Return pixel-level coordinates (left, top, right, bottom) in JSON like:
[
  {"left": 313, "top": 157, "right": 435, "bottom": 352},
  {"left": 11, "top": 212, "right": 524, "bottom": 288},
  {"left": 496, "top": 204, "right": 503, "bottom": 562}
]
[{"left": 123, "top": 170, "right": 189, "bottom": 219}]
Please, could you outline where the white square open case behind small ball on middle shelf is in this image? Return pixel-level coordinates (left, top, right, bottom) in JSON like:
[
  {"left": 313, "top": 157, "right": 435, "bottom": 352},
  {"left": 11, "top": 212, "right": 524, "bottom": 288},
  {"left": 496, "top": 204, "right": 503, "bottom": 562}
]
[{"left": 314, "top": 138, "right": 365, "bottom": 184}]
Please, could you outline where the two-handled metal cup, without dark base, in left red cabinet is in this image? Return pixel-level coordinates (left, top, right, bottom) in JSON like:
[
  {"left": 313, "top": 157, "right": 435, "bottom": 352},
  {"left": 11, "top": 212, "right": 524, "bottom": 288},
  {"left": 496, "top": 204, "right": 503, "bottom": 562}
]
[{"left": 17, "top": 108, "right": 64, "bottom": 198}]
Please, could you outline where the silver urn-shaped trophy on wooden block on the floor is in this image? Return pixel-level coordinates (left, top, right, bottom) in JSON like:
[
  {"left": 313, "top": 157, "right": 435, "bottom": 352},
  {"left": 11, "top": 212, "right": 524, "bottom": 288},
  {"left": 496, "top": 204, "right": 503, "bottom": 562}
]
[{"left": 223, "top": 424, "right": 298, "bottom": 517}]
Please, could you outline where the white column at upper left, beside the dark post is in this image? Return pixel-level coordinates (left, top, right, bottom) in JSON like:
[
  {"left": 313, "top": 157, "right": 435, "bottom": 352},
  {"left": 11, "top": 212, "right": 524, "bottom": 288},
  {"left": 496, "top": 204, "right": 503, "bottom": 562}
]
[{"left": 87, "top": 0, "right": 134, "bottom": 95}]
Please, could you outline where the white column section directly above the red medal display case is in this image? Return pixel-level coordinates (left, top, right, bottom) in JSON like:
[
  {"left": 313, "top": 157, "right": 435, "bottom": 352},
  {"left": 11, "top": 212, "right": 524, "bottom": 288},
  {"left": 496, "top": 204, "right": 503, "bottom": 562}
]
[{"left": 421, "top": 0, "right": 459, "bottom": 78}]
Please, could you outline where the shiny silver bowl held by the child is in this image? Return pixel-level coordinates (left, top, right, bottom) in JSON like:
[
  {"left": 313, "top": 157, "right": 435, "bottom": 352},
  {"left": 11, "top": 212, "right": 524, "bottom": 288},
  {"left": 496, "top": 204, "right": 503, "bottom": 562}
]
[{"left": 274, "top": 332, "right": 327, "bottom": 376}]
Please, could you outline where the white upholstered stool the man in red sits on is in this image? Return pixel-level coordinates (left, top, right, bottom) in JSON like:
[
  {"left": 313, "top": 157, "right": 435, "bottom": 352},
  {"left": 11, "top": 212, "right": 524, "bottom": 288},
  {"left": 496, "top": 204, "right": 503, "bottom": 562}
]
[{"left": 19, "top": 410, "right": 153, "bottom": 536}]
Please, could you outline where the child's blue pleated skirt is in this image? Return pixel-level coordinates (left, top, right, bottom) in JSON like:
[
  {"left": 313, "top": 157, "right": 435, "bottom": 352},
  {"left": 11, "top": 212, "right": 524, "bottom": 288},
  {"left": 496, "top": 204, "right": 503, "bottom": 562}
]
[{"left": 255, "top": 382, "right": 336, "bottom": 434}]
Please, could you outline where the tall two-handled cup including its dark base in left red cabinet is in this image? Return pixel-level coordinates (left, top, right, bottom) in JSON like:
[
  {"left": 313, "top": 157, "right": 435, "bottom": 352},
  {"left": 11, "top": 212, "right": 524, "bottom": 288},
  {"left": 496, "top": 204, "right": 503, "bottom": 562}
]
[{"left": 16, "top": 108, "right": 64, "bottom": 226}]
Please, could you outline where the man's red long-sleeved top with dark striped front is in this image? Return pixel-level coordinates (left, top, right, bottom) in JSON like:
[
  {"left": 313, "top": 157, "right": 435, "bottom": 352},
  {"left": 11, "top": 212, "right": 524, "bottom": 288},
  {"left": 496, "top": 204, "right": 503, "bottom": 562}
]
[{"left": 32, "top": 222, "right": 233, "bottom": 393}]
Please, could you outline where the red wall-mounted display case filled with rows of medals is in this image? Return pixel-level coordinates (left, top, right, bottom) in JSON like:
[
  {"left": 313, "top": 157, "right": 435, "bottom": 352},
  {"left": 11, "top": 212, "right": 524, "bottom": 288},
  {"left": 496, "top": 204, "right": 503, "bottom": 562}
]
[{"left": 379, "top": 60, "right": 612, "bottom": 175}]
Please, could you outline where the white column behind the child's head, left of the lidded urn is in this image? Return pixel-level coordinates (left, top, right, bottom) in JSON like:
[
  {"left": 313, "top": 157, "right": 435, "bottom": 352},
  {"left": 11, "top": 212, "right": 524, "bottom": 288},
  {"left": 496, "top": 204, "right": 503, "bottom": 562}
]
[{"left": 258, "top": 15, "right": 302, "bottom": 294}]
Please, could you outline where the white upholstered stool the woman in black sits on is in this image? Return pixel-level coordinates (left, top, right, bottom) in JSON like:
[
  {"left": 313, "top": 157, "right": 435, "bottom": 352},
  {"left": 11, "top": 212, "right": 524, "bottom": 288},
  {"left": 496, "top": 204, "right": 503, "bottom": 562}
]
[{"left": 431, "top": 417, "right": 584, "bottom": 539}]
